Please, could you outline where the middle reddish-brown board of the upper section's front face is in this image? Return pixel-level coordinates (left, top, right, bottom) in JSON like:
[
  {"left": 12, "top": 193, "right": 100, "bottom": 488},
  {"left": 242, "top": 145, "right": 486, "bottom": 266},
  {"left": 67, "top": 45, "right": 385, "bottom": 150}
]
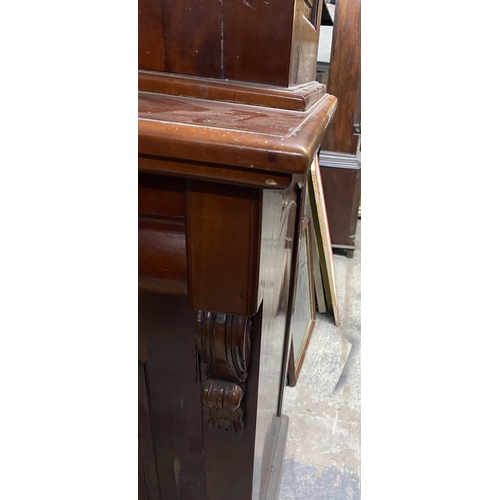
[{"left": 161, "top": 0, "right": 222, "bottom": 78}]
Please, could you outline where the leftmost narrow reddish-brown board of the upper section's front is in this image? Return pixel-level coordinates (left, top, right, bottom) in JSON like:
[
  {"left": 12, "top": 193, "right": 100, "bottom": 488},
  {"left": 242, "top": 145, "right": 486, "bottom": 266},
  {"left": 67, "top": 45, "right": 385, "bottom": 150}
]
[{"left": 138, "top": 0, "right": 164, "bottom": 70}]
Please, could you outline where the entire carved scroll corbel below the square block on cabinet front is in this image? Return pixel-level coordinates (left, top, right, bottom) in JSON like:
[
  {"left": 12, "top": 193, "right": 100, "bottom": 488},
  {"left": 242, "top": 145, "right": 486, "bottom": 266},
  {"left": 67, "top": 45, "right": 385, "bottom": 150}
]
[{"left": 196, "top": 311, "right": 252, "bottom": 434}]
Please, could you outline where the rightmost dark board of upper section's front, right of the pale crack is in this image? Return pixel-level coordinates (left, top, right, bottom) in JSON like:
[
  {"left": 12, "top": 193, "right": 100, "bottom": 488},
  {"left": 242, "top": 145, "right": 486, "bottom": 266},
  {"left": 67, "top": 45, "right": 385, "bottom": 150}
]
[{"left": 223, "top": 0, "right": 292, "bottom": 87}]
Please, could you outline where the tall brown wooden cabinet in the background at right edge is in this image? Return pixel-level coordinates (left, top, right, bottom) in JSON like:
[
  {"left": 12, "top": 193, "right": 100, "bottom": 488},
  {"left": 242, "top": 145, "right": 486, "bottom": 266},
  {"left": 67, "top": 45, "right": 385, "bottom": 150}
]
[{"left": 319, "top": 0, "right": 361, "bottom": 257}]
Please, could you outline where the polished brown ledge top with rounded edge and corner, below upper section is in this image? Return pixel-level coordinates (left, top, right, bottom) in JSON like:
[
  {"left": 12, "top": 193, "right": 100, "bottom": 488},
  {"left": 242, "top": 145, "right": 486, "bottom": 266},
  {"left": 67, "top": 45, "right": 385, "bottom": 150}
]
[{"left": 139, "top": 92, "right": 337, "bottom": 174}]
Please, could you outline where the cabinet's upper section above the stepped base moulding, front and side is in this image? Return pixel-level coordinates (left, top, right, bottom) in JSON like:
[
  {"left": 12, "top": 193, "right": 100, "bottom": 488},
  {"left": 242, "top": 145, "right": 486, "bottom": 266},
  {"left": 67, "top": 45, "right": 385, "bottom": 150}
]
[{"left": 139, "top": 0, "right": 321, "bottom": 87}]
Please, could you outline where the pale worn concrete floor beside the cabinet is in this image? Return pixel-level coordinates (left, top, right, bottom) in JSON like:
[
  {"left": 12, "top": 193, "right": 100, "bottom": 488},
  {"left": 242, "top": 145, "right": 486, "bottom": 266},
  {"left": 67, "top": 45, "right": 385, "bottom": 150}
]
[{"left": 279, "top": 220, "right": 361, "bottom": 500}]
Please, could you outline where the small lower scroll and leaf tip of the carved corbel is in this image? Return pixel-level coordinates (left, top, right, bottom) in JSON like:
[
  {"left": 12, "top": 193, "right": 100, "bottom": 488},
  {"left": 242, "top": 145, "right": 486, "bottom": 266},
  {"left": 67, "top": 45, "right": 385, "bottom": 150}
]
[{"left": 201, "top": 379, "right": 244, "bottom": 434}]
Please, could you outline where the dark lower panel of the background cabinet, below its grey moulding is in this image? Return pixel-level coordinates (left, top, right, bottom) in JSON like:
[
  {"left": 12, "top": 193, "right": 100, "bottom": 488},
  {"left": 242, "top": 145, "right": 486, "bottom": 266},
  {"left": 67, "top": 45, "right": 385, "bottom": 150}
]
[{"left": 321, "top": 167, "right": 361, "bottom": 248}]
